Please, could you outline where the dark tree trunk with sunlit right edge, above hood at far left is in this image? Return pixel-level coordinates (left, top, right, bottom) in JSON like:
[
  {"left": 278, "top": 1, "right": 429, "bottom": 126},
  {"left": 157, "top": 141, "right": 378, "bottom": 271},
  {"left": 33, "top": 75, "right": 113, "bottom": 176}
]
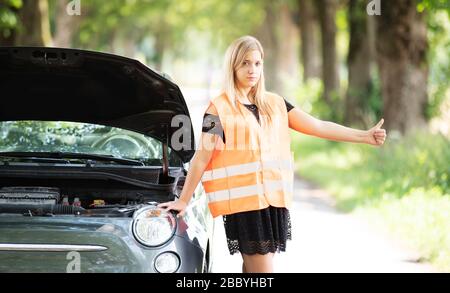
[{"left": 16, "top": 0, "right": 52, "bottom": 46}]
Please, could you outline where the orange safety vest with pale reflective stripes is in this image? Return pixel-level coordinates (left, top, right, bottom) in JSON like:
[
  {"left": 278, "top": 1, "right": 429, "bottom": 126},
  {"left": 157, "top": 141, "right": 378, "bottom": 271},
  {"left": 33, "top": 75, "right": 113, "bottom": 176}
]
[{"left": 202, "top": 93, "right": 294, "bottom": 217}]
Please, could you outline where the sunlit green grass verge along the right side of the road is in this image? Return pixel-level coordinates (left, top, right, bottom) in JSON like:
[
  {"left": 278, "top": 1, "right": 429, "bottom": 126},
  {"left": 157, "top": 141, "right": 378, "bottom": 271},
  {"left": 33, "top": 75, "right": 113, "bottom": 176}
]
[{"left": 293, "top": 132, "right": 450, "bottom": 272}]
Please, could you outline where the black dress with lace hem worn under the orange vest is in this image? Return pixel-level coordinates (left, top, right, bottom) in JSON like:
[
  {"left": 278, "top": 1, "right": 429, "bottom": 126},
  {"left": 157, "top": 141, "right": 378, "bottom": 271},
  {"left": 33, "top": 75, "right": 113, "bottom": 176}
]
[{"left": 202, "top": 100, "right": 294, "bottom": 254}]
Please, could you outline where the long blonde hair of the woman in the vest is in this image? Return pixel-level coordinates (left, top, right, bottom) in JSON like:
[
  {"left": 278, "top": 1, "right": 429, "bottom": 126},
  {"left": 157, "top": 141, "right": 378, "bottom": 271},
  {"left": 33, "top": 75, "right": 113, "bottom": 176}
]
[{"left": 223, "top": 36, "right": 274, "bottom": 122}]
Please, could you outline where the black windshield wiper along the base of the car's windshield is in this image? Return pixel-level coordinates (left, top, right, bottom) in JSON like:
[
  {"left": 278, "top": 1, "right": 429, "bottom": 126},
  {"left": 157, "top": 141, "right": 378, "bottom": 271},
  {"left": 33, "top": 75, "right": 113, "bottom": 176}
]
[{"left": 0, "top": 152, "right": 145, "bottom": 166}]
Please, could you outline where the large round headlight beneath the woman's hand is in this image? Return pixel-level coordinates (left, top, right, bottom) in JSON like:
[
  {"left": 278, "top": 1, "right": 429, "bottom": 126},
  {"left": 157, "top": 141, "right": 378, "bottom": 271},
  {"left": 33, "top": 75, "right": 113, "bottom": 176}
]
[{"left": 133, "top": 206, "right": 177, "bottom": 246}]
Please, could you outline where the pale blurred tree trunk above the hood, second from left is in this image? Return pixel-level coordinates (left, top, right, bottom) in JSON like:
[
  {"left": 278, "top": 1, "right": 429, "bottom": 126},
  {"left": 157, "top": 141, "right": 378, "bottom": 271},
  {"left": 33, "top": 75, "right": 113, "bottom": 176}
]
[{"left": 53, "top": 0, "right": 82, "bottom": 48}]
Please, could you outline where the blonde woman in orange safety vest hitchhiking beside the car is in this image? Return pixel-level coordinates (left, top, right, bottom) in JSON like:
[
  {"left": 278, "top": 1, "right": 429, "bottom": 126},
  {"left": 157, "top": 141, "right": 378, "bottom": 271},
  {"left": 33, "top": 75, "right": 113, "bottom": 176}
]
[{"left": 159, "top": 36, "right": 386, "bottom": 273}]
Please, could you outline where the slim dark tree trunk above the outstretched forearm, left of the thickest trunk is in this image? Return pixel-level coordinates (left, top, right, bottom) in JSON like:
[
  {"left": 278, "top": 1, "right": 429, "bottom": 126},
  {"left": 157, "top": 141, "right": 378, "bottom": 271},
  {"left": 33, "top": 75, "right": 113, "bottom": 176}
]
[{"left": 345, "top": 0, "right": 373, "bottom": 127}]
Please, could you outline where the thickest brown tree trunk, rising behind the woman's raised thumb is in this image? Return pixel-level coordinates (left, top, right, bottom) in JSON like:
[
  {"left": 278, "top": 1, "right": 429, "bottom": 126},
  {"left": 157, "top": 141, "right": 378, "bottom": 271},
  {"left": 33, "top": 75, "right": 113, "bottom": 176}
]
[{"left": 377, "top": 0, "right": 428, "bottom": 134}]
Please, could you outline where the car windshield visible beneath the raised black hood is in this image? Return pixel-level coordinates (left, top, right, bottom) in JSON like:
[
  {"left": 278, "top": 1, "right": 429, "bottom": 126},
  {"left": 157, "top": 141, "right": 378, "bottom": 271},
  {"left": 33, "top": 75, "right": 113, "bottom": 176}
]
[{"left": 0, "top": 121, "right": 181, "bottom": 165}]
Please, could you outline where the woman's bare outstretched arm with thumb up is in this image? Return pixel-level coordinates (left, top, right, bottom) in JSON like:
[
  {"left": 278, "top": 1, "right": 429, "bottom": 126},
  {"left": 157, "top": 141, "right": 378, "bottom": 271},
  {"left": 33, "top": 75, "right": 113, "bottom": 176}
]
[{"left": 288, "top": 108, "right": 386, "bottom": 146}]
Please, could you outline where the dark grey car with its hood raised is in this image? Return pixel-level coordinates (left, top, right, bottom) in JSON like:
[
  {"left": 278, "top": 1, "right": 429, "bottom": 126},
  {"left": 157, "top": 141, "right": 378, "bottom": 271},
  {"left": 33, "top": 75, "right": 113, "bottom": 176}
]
[{"left": 0, "top": 47, "right": 214, "bottom": 273}]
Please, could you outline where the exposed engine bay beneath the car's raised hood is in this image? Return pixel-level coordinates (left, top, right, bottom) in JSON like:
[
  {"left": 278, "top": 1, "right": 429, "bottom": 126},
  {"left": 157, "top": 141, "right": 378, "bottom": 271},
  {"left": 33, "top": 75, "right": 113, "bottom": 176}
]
[{"left": 0, "top": 186, "right": 178, "bottom": 217}]
